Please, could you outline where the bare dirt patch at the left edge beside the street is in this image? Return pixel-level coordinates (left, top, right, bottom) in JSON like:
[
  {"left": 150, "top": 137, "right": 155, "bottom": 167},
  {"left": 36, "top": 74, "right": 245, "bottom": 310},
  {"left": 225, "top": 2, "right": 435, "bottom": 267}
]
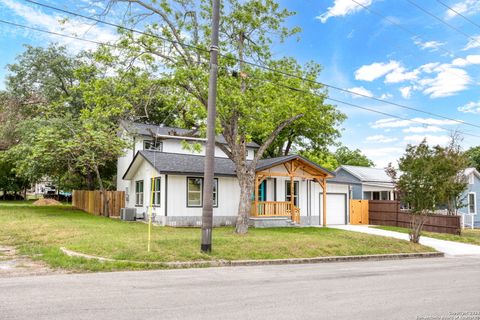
[{"left": 0, "top": 246, "right": 57, "bottom": 278}]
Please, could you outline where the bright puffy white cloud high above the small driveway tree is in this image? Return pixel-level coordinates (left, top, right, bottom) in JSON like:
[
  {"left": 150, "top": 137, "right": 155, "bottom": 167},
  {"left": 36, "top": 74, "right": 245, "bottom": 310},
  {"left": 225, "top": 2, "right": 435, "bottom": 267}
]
[{"left": 418, "top": 65, "right": 471, "bottom": 98}]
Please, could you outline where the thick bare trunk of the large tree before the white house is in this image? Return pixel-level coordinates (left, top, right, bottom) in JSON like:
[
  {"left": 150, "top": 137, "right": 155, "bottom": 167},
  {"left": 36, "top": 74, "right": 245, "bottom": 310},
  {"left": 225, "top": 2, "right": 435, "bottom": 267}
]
[{"left": 235, "top": 171, "right": 255, "bottom": 234}]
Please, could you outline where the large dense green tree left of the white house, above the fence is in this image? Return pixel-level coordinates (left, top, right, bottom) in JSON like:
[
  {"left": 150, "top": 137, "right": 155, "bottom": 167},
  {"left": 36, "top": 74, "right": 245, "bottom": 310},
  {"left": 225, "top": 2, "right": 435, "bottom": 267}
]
[{"left": 0, "top": 45, "right": 173, "bottom": 198}]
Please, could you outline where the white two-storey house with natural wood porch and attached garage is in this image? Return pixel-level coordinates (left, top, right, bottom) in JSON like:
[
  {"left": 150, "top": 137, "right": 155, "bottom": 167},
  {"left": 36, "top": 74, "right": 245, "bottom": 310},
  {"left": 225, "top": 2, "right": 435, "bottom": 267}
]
[{"left": 117, "top": 122, "right": 349, "bottom": 226}]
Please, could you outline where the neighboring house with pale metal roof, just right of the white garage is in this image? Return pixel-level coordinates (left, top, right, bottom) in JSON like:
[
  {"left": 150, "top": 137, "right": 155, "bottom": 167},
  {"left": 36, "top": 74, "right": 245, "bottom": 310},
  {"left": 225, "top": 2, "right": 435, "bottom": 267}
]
[{"left": 335, "top": 165, "right": 395, "bottom": 200}]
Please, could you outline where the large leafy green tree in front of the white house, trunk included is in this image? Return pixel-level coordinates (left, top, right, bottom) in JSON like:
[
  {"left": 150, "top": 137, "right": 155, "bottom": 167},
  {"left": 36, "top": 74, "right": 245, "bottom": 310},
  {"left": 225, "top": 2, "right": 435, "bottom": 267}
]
[{"left": 105, "top": 0, "right": 344, "bottom": 233}]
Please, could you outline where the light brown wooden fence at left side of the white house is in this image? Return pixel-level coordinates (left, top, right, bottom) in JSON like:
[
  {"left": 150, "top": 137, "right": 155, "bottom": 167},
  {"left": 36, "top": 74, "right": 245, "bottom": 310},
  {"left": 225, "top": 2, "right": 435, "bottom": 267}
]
[{"left": 72, "top": 190, "right": 125, "bottom": 217}]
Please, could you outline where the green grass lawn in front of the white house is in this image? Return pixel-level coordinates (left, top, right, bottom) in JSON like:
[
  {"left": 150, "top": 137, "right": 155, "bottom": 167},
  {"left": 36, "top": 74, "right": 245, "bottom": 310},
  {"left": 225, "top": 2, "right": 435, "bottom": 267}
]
[{"left": 0, "top": 202, "right": 434, "bottom": 270}]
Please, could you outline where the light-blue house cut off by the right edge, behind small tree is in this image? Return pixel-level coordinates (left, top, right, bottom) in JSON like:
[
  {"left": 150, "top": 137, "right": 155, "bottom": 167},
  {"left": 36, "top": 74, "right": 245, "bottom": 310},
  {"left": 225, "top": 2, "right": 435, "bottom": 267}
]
[{"left": 458, "top": 168, "right": 480, "bottom": 227}]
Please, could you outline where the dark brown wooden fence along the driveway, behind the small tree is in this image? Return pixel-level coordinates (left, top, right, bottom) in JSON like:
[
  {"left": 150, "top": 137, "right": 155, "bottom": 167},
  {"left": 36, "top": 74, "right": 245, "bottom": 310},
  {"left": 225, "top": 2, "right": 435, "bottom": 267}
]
[{"left": 368, "top": 200, "right": 461, "bottom": 234}]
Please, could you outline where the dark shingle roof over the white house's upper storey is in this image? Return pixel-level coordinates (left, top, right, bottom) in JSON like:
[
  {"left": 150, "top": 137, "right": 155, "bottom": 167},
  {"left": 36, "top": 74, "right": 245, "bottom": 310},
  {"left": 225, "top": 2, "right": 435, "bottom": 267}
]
[{"left": 121, "top": 121, "right": 259, "bottom": 148}]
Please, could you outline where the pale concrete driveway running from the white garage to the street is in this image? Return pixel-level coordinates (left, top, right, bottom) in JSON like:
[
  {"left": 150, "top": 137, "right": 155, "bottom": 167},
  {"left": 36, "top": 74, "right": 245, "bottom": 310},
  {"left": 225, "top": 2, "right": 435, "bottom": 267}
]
[{"left": 328, "top": 225, "right": 480, "bottom": 256}]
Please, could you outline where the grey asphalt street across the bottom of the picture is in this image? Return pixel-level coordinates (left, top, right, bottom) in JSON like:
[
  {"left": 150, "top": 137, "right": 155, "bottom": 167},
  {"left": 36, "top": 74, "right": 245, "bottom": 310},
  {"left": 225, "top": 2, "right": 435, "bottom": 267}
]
[{"left": 0, "top": 256, "right": 480, "bottom": 320}]
